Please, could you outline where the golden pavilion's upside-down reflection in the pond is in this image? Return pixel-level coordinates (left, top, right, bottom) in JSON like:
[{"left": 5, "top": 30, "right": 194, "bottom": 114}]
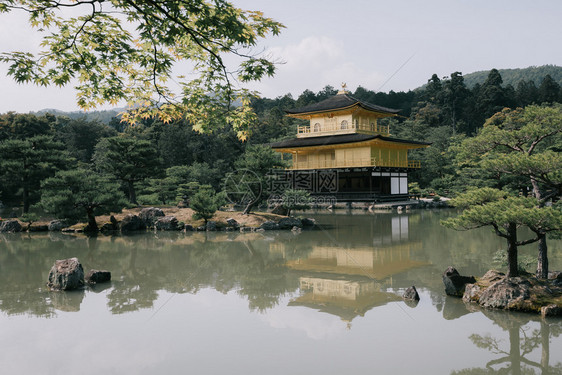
[{"left": 270, "top": 215, "right": 426, "bottom": 322}]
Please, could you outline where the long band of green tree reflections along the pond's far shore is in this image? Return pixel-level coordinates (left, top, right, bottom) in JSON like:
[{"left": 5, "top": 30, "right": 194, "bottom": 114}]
[{"left": 0, "top": 216, "right": 528, "bottom": 322}]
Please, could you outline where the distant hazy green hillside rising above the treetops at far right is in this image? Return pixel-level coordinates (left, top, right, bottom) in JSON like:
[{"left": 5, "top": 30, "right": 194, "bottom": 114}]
[{"left": 464, "top": 65, "right": 562, "bottom": 88}]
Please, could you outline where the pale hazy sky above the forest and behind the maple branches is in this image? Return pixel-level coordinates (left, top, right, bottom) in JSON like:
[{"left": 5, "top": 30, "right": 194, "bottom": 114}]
[{"left": 0, "top": 0, "right": 562, "bottom": 113}]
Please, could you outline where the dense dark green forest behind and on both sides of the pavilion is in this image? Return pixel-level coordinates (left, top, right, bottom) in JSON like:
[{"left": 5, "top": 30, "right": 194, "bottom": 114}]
[{"left": 0, "top": 67, "right": 562, "bottom": 220}]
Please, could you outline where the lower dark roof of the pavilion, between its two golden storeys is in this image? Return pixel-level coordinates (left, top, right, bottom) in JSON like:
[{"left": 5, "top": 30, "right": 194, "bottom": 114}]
[{"left": 270, "top": 133, "right": 431, "bottom": 148}]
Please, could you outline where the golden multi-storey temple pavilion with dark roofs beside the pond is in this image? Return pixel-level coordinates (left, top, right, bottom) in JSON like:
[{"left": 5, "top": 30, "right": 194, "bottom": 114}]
[{"left": 271, "top": 85, "right": 429, "bottom": 201}]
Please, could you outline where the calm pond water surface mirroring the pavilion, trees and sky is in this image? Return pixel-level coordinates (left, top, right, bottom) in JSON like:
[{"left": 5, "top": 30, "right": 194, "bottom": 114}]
[{"left": 0, "top": 211, "right": 562, "bottom": 374}]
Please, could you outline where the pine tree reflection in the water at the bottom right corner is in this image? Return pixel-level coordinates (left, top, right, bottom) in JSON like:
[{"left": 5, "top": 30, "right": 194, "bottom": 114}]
[{"left": 453, "top": 310, "right": 562, "bottom": 375}]
